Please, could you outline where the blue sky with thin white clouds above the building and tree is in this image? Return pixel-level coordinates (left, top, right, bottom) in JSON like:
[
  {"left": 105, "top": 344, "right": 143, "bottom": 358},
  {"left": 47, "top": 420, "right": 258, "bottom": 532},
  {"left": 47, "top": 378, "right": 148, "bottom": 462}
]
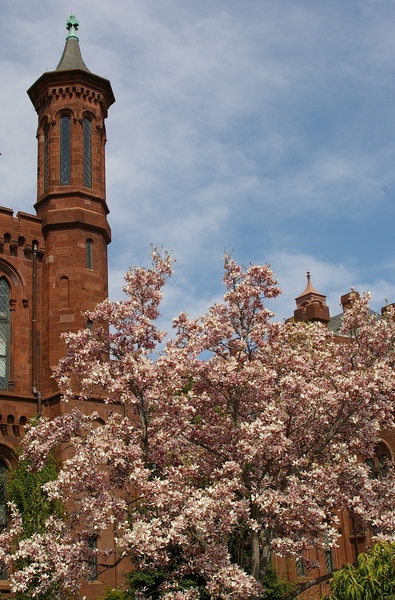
[{"left": 0, "top": 0, "right": 395, "bottom": 328}]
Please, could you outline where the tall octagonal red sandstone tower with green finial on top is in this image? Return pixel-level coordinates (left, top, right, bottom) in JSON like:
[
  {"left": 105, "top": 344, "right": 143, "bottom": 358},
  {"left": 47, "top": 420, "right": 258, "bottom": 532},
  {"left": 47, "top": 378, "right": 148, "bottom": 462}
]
[{"left": 28, "top": 16, "right": 115, "bottom": 398}]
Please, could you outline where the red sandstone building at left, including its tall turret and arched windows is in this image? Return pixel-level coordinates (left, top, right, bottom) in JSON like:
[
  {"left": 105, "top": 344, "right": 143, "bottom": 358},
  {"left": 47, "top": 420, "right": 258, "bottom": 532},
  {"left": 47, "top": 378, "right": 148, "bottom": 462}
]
[{"left": 0, "top": 16, "right": 119, "bottom": 599}]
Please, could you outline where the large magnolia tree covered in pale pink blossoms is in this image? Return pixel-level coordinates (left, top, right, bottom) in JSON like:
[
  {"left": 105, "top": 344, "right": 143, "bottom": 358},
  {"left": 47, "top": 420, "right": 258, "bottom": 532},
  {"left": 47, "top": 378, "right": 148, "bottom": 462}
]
[{"left": 0, "top": 251, "right": 395, "bottom": 600}]
